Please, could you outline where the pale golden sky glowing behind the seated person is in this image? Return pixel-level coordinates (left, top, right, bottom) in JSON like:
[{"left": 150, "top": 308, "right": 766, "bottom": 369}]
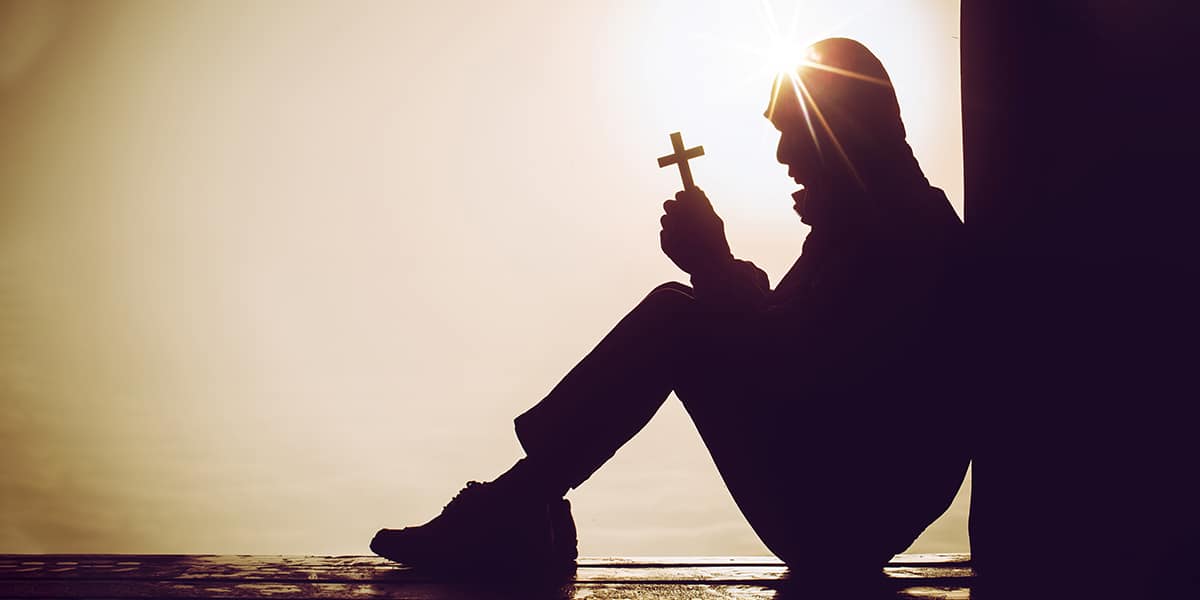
[{"left": 0, "top": 0, "right": 967, "bottom": 554}]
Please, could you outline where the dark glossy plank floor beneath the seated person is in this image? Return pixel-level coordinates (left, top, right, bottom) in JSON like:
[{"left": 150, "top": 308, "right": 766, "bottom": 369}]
[{"left": 0, "top": 554, "right": 973, "bottom": 600}]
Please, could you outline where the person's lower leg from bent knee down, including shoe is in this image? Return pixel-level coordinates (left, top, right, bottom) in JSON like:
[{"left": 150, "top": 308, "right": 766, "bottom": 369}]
[{"left": 371, "top": 283, "right": 694, "bottom": 574}]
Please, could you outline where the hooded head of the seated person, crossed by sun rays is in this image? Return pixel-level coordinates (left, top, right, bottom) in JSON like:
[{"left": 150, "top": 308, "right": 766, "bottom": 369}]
[{"left": 766, "top": 38, "right": 924, "bottom": 225}]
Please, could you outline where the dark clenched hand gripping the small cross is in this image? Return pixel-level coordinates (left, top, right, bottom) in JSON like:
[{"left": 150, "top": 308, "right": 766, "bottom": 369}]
[{"left": 659, "top": 188, "right": 733, "bottom": 275}]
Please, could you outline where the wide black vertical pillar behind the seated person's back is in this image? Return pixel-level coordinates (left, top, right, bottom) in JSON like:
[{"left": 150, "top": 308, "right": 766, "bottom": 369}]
[{"left": 961, "top": 0, "right": 1200, "bottom": 598}]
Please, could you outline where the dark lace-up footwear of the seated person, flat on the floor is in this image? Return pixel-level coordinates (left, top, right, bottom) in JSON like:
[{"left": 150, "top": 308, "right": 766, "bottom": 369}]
[{"left": 371, "top": 481, "right": 577, "bottom": 575}]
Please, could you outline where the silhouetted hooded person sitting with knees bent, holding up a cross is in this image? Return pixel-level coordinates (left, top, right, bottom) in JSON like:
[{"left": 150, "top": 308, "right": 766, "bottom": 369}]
[{"left": 371, "top": 38, "right": 966, "bottom": 574}]
